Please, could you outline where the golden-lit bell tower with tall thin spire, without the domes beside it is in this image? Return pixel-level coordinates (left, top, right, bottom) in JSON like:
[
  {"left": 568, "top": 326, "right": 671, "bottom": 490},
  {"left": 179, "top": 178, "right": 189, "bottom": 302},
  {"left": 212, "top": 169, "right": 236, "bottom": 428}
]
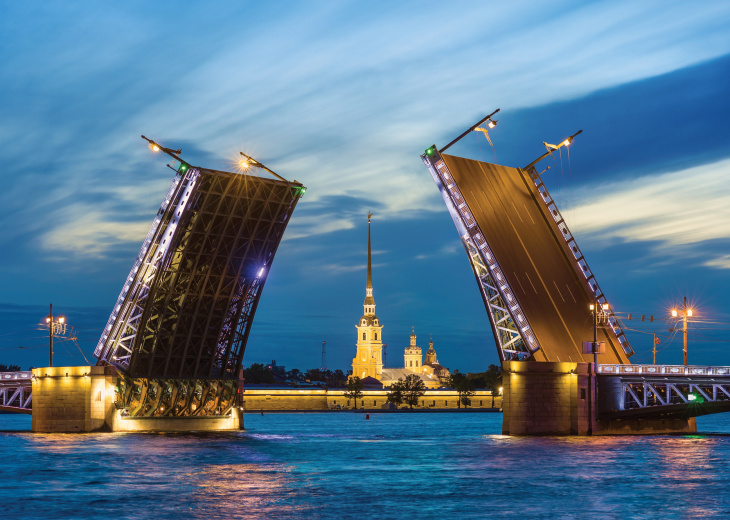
[{"left": 352, "top": 213, "right": 383, "bottom": 380}]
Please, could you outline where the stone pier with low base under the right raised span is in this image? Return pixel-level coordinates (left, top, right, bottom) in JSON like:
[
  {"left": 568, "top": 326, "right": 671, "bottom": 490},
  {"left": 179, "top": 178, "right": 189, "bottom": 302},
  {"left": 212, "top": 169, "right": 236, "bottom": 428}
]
[{"left": 502, "top": 361, "right": 697, "bottom": 435}]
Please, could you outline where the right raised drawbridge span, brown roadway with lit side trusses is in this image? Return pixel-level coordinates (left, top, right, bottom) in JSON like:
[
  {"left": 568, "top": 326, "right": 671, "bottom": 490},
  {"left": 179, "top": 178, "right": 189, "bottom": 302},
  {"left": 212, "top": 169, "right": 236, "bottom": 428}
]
[{"left": 421, "top": 147, "right": 633, "bottom": 364}]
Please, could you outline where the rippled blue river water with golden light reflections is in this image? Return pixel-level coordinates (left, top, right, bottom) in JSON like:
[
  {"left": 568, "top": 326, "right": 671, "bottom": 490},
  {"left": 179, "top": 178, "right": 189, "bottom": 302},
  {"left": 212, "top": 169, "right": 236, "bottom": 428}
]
[{"left": 0, "top": 413, "right": 730, "bottom": 520}]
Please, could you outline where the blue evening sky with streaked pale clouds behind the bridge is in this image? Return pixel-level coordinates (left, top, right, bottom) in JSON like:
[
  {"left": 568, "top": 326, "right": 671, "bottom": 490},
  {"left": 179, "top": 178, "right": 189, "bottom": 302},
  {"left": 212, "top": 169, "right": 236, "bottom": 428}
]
[{"left": 0, "top": 1, "right": 730, "bottom": 371}]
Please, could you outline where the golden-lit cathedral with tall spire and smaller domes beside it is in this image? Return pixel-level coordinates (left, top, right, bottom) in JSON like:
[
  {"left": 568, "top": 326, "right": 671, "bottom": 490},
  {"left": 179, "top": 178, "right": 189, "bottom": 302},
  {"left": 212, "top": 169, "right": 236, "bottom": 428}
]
[{"left": 352, "top": 213, "right": 449, "bottom": 388}]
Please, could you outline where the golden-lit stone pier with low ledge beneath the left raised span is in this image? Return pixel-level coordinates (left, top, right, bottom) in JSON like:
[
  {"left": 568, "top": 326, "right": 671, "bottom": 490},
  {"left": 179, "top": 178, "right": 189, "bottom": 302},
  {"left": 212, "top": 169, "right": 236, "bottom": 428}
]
[{"left": 31, "top": 366, "right": 243, "bottom": 433}]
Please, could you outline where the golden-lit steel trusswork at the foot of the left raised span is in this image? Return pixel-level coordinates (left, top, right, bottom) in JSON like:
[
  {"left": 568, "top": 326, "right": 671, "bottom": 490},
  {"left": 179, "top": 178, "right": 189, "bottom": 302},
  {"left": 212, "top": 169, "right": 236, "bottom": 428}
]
[{"left": 114, "top": 374, "right": 238, "bottom": 417}]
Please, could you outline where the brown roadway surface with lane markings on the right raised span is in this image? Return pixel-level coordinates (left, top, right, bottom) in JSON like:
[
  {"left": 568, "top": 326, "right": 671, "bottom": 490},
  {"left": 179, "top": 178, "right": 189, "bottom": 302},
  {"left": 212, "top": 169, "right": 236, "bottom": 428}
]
[{"left": 442, "top": 154, "right": 629, "bottom": 364}]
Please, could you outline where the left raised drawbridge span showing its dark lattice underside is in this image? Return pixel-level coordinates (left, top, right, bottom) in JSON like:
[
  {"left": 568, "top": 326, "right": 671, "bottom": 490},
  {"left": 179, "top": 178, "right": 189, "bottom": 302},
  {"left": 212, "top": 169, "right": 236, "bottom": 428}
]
[{"left": 94, "top": 157, "right": 305, "bottom": 379}]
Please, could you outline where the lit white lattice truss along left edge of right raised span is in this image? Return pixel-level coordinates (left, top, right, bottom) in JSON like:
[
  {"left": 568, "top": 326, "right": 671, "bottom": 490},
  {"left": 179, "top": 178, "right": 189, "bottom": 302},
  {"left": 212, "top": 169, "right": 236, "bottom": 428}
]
[{"left": 421, "top": 151, "right": 540, "bottom": 361}]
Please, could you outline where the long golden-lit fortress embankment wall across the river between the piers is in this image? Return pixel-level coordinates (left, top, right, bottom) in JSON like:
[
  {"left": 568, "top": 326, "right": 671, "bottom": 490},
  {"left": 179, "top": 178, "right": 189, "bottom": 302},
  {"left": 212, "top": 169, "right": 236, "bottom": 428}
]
[{"left": 243, "top": 388, "right": 502, "bottom": 412}]
